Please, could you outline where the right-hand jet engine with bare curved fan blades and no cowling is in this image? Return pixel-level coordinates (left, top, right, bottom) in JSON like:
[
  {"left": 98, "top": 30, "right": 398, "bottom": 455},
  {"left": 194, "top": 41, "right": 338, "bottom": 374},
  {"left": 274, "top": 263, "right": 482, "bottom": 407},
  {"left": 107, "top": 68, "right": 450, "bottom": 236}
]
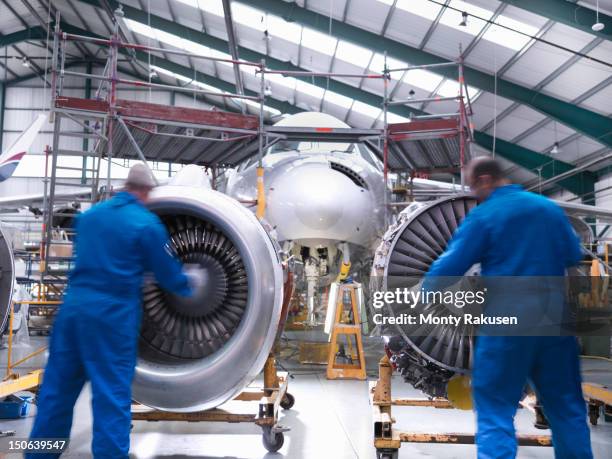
[{"left": 377, "top": 196, "right": 476, "bottom": 397}]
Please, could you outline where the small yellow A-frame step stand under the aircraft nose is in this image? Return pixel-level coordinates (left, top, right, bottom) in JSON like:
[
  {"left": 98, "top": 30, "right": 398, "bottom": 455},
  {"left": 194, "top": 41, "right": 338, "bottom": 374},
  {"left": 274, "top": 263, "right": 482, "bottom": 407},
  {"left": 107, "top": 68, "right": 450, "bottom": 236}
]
[{"left": 327, "top": 283, "right": 366, "bottom": 380}]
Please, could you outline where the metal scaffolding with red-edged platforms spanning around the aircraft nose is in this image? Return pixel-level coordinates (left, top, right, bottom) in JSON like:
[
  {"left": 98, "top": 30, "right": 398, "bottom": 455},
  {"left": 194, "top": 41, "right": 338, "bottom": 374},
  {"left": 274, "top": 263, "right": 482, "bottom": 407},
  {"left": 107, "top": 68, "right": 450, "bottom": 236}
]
[{"left": 41, "top": 10, "right": 472, "bottom": 284}]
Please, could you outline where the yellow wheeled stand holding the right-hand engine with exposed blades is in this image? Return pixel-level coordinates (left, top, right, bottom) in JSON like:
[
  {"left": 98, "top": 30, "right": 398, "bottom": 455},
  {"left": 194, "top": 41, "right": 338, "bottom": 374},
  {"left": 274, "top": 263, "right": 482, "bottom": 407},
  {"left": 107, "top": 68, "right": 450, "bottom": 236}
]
[{"left": 370, "top": 356, "right": 552, "bottom": 459}]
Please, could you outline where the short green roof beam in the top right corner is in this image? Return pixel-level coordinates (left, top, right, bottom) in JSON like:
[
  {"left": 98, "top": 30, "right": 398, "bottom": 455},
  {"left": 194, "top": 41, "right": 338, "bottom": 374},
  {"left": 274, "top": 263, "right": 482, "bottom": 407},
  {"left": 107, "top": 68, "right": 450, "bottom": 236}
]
[{"left": 501, "top": 0, "right": 612, "bottom": 40}]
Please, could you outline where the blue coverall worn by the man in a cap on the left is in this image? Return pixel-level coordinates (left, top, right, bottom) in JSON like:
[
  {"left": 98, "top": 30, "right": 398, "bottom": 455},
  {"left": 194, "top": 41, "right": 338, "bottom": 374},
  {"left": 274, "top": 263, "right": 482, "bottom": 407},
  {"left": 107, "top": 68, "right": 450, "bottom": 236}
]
[{"left": 26, "top": 192, "right": 191, "bottom": 459}]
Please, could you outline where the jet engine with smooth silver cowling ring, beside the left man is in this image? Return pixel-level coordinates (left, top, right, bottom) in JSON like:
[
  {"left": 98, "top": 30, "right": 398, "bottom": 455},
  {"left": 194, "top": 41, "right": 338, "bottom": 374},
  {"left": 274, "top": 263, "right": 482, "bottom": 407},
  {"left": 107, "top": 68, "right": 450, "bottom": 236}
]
[{"left": 133, "top": 185, "right": 284, "bottom": 412}]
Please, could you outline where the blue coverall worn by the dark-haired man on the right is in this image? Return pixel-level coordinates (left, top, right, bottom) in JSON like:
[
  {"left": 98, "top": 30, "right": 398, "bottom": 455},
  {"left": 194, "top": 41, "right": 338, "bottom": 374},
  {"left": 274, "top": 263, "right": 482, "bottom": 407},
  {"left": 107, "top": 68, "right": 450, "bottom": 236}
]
[{"left": 426, "top": 185, "right": 592, "bottom": 459}]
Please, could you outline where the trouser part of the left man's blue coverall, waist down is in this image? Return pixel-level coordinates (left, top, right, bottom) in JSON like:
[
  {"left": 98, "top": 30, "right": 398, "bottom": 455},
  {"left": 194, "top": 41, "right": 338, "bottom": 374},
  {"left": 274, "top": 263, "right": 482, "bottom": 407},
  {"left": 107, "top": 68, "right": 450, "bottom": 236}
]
[{"left": 26, "top": 300, "right": 139, "bottom": 459}]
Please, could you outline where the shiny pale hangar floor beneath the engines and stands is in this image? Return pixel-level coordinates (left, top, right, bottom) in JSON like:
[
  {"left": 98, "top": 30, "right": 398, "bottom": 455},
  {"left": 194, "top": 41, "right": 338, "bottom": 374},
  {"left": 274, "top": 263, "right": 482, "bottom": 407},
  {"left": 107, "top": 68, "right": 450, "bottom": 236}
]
[{"left": 0, "top": 338, "right": 612, "bottom": 459}]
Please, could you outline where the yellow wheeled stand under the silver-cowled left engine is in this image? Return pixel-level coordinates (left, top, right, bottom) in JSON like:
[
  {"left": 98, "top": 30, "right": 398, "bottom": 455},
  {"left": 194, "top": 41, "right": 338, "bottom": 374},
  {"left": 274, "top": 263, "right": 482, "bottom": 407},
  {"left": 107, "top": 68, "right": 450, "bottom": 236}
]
[{"left": 132, "top": 355, "right": 295, "bottom": 452}]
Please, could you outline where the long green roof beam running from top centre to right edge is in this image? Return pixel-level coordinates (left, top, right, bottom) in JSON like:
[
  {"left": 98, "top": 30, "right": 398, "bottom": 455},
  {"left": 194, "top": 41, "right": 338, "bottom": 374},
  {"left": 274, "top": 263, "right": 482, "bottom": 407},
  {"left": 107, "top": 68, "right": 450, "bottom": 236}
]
[{"left": 244, "top": 0, "right": 612, "bottom": 147}]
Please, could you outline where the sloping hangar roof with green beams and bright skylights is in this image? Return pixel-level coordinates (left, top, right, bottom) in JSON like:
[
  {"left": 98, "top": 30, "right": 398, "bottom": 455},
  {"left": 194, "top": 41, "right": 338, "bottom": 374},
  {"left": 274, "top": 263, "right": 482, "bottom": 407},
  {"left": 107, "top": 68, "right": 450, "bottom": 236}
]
[{"left": 0, "top": 0, "right": 612, "bottom": 198}]
